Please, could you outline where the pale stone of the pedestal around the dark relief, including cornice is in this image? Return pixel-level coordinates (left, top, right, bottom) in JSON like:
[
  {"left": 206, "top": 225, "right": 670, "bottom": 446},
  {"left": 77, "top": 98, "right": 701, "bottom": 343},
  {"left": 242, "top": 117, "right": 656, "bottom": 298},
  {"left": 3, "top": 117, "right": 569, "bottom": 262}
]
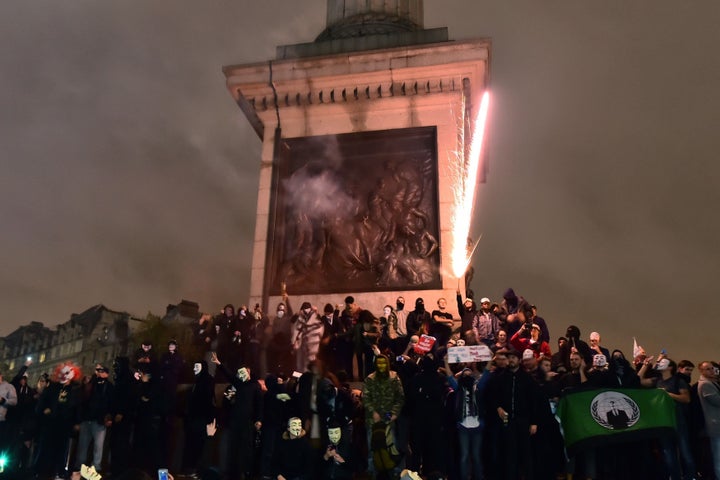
[{"left": 223, "top": 40, "right": 490, "bottom": 314}]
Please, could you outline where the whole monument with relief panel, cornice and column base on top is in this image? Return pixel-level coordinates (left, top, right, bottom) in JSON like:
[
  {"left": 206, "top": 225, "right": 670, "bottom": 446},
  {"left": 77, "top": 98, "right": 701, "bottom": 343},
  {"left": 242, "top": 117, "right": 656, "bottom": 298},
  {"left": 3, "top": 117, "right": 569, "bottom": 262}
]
[{"left": 223, "top": 0, "right": 490, "bottom": 315}]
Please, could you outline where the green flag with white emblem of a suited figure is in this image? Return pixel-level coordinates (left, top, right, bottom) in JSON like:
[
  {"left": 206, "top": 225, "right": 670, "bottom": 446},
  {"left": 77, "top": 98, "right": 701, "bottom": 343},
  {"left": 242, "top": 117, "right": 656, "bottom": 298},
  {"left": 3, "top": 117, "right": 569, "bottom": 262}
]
[{"left": 557, "top": 388, "right": 675, "bottom": 453}]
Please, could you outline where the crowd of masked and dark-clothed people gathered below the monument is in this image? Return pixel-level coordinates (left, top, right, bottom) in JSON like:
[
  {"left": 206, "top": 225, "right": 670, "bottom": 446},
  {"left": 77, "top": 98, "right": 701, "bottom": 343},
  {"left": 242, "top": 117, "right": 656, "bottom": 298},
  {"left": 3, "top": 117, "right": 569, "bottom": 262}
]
[{"left": 0, "top": 289, "right": 720, "bottom": 480}]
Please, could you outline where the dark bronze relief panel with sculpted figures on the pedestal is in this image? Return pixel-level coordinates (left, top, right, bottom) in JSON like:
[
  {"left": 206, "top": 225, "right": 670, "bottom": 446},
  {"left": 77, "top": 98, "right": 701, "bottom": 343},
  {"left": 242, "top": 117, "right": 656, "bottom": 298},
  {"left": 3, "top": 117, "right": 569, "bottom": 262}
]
[{"left": 270, "top": 128, "right": 440, "bottom": 293}]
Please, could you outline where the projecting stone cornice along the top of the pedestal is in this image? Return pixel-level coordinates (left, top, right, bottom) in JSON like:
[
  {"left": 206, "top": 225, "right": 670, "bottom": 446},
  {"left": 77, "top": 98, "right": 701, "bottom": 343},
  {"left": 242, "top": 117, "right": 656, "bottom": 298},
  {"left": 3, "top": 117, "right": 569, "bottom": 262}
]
[{"left": 223, "top": 40, "right": 490, "bottom": 127}]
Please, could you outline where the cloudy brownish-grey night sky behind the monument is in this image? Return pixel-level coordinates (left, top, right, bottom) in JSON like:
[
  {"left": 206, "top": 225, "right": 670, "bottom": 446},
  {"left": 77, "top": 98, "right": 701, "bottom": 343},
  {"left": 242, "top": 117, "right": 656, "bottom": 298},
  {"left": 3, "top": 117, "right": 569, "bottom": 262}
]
[{"left": 0, "top": 0, "right": 720, "bottom": 368}]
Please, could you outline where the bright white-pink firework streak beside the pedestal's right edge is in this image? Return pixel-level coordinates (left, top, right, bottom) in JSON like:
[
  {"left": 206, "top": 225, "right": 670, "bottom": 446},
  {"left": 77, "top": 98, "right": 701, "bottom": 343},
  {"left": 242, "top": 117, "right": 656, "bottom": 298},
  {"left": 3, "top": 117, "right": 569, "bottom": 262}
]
[{"left": 452, "top": 90, "right": 490, "bottom": 278}]
